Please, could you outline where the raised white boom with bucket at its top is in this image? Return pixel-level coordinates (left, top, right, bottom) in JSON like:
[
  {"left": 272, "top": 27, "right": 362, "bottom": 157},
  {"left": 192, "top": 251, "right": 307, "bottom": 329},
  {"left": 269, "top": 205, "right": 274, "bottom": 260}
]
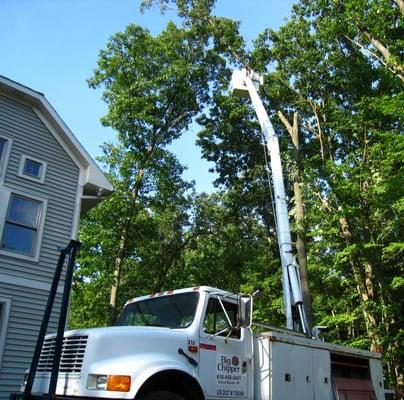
[{"left": 231, "top": 68, "right": 310, "bottom": 333}]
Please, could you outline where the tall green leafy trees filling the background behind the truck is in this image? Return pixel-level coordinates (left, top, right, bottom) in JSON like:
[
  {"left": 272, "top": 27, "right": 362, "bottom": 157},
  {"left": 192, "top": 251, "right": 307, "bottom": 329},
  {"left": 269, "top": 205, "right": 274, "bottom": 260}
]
[{"left": 71, "top": 0, "right": 404, "bottom": 388}]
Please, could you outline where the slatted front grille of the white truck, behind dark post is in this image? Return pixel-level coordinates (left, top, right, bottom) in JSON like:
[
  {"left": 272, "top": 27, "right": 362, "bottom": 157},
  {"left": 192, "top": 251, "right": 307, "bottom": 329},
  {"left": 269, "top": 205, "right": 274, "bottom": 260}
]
[{"left": 38, "top": 336, "right": 88, "bottom": 372}]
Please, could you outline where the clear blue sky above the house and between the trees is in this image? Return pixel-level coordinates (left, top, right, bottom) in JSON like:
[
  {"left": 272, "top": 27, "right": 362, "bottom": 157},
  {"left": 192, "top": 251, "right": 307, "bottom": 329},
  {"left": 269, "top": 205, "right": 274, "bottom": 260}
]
[{"left": 0, "top": 0, "right": 295, "bottom": 191}]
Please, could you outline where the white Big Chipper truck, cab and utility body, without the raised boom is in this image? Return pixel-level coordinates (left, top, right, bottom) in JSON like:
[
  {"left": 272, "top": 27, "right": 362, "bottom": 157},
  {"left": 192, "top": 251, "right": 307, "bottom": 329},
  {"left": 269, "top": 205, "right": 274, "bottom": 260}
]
[{"left": 22, "top": 287, "right": 384, "bottom": 400}]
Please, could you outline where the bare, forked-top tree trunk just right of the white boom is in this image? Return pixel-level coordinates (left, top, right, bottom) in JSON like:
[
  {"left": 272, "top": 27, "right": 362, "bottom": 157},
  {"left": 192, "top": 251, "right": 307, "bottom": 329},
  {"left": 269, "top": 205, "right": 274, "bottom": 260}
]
[{"left": 278, "top": 111, "right": 313, "bottom": 327}]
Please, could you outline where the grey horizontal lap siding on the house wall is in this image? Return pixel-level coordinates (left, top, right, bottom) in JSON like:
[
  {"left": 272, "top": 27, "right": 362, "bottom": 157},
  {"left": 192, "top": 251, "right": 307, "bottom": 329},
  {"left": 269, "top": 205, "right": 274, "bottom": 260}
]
[{"left": 0, "top": 95, "right": 80, "bottom": 400}]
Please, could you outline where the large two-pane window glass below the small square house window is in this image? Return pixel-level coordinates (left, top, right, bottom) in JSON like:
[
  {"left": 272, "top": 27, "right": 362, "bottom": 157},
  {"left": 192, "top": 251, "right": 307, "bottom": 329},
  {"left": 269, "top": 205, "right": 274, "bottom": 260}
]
[{"left": 1, "top": 194, "right": 42, "bottom": 256}]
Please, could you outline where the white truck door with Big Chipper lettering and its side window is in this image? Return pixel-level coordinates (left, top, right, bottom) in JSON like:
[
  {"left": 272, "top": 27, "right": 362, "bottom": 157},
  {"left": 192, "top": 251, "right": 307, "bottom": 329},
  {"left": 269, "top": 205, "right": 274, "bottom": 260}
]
[{"left": 199, "top": 295, "right": 253, "bottom": 399}]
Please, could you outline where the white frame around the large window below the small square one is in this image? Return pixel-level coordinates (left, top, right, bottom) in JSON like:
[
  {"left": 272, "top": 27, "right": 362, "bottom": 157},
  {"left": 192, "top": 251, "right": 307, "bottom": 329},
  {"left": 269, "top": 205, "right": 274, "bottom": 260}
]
[{"left": 0, "top": 189, "right": 48, "bottom": 261}]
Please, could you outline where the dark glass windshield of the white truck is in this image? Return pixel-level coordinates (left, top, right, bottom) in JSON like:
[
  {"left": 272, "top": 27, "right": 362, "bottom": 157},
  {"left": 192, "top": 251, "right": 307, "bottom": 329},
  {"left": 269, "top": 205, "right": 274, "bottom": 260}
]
[{"left": 116, "top": 292, "right": 199, "bottom": 328}]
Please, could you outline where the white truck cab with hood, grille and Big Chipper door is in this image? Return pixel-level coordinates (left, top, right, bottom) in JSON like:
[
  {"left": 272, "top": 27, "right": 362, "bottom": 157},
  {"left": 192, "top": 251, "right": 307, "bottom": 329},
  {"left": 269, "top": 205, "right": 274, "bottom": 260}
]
[{"left": 25, "top": 286, "right": 253, "bottom": 400}]
